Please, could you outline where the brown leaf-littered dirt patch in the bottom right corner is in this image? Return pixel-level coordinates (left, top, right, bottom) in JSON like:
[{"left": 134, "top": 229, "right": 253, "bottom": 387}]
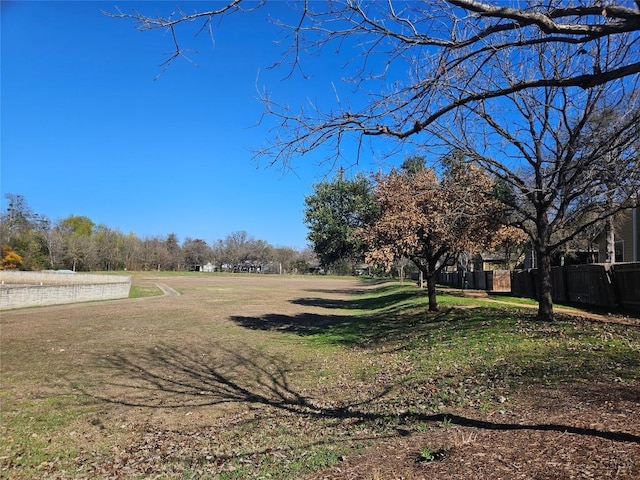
[{"left": 307, "top": 384, "right": 640, "bottom": 480}]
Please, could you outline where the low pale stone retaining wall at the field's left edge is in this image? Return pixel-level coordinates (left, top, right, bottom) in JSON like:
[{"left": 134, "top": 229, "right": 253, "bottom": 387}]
[{"left": 0, "top": 270, "right": 131, "bottom": 310}]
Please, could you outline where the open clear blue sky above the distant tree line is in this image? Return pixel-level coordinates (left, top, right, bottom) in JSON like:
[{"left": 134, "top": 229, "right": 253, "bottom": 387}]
[{"left": 0, "top": 0, "right": 398, "bottom": 248}]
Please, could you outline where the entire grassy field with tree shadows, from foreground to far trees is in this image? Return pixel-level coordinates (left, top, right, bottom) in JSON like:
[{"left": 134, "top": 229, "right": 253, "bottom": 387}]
[{"left": 0, "top": 273, "right": 640, "bottom": 479}]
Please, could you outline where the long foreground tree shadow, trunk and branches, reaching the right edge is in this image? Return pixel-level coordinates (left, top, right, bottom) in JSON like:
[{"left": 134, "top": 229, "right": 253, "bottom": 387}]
[{"left": 85, "top": 345, "right": 640, "bottom": 444}]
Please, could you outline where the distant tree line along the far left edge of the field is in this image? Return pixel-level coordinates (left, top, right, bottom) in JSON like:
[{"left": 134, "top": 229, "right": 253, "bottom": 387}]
[{"left": 0, "top": 194, "right": 315, "bottom": 273}]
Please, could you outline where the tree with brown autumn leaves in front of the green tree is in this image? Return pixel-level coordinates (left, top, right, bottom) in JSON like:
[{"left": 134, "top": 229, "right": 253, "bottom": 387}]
[{"left": 363, "top": 158, "right": 500, "bottom": 311}]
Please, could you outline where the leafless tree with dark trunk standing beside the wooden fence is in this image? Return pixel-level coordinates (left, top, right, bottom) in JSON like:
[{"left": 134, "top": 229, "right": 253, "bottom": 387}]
[{"left": 432, "top": 45, "right": 640, "bottom": 320}]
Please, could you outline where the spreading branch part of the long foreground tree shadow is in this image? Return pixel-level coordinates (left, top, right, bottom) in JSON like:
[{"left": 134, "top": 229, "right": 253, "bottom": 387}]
[{"left": 84, "top": 345, "right": 391, "bottom": 418}]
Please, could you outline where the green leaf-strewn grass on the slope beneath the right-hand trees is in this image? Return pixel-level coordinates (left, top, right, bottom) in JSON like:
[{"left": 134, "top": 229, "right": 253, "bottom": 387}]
[{"left": 296, "top": 285, "right": 640, "bottom": 413}]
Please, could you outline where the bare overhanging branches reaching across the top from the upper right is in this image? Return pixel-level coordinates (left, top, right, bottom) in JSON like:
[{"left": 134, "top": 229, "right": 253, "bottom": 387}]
[{"left": 107, "top": 0, "right": 640, "bottom": 163}]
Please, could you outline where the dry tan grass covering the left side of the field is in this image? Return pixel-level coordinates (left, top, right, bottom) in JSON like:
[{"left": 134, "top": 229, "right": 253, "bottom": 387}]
[{"left": 0, "top": 274, "right": 376, "bottom": 478}]
